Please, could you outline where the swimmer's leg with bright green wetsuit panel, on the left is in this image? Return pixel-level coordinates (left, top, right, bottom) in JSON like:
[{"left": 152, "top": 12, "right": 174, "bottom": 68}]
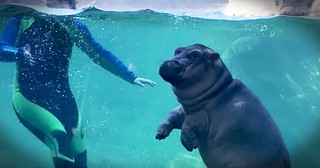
[{"left": 13, "top": 89, "right": 74, "bottom": 168}]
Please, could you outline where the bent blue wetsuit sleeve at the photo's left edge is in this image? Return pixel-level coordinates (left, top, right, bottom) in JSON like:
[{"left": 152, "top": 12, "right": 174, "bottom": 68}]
[{"left": 0, "top": 17, "right": 23, "bottom": 62}]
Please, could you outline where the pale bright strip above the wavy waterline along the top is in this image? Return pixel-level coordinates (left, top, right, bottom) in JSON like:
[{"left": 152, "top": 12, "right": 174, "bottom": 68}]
[{"left": 0, "top": 0, "right": 320, "bottom": 20}]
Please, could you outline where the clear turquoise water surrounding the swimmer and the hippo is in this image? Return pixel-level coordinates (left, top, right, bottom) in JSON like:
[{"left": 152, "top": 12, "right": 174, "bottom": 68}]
[{"left": 0, "top": 12, "right": 320, "bottom": 168}]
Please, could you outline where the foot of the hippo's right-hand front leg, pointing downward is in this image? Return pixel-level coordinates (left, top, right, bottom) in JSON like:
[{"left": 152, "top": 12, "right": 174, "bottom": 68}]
[{"left": 180, "top": 129, "right": 198, "bottom": 152}]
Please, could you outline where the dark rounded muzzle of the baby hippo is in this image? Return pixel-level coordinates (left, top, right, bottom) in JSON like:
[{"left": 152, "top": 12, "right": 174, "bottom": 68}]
[{"left": 159, "top": 60, "right": 185, "bottom": 86}]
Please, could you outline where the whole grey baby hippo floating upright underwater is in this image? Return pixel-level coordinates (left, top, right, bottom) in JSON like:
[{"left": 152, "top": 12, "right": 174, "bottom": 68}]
[{"left": 156, "top": 44, "right": 290, "bottom": 168}]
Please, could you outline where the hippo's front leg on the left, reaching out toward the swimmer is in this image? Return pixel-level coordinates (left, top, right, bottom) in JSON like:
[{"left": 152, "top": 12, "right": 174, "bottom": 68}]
[{"left": 156, "top": 106, "right": 185, "bottom": 140}]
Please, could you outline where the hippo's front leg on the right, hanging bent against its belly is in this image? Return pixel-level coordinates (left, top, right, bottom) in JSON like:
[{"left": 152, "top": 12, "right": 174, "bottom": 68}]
[{"left": 180, "top": 110, "right": 210, "bottom": 151}]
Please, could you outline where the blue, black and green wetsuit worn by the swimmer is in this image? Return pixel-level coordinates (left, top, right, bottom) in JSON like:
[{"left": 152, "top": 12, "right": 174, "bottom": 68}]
[{"left": 0, "top": 17, "right": 136, "bottom": 168}]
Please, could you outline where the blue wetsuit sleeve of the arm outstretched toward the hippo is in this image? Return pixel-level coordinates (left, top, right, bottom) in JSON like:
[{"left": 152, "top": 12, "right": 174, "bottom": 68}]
[{"left": 67, "top": 20, "right": 137, "bottom": 83}]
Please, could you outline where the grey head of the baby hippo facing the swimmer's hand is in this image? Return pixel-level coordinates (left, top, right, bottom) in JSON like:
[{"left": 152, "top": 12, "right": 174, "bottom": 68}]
[{"left": 159, "top": 44, "right": 232, "bottom": 103}]
